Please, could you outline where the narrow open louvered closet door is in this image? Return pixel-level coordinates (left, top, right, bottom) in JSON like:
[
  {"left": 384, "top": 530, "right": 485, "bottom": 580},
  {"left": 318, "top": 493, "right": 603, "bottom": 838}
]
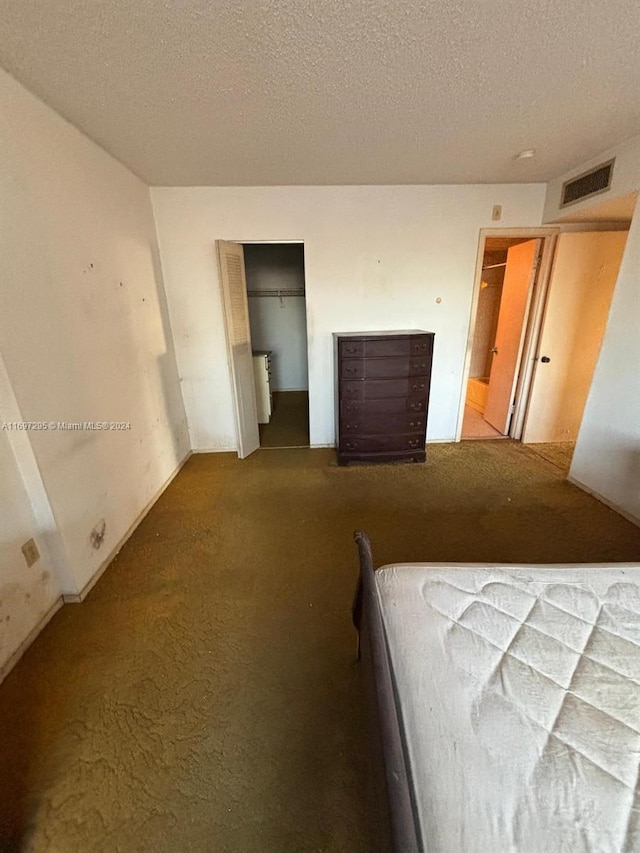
[{"left": 216, "top": 240, "right": 260, "bottom": 459}]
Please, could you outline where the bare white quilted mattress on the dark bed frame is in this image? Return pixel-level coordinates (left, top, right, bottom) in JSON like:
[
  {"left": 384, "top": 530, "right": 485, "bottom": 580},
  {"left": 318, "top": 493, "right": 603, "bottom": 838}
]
[{"left": 376, "top": 564, "right": 640, "bottom": 853}]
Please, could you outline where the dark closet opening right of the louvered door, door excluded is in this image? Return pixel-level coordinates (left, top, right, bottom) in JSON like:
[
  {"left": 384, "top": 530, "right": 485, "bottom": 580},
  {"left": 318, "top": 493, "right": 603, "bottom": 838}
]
[{"left": 243, "top": 243, "right": 309, "bottom": 449}]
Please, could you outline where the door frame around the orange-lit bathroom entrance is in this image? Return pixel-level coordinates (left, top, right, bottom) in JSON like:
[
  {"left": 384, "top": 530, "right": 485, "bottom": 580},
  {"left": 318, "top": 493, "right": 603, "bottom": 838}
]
[{"left": 455, "top": 225, "right": 561, "bottom": 441}]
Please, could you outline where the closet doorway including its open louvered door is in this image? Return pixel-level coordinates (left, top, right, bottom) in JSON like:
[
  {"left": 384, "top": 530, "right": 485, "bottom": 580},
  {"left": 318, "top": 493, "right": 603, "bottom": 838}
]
[{"left": 216, "top": 240, "right": 309, "bottom": 459}]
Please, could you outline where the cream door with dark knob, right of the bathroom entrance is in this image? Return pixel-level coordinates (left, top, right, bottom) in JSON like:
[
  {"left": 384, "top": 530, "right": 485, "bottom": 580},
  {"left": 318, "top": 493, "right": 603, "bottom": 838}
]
[{"left": 522, "top": 231, "right": 627, "bottom": 443}]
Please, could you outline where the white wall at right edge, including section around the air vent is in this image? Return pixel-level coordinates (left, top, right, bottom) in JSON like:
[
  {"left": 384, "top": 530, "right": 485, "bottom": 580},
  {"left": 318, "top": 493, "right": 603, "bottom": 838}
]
[{"left": 544, "top": 137, "right": 640, "bottom": 521}]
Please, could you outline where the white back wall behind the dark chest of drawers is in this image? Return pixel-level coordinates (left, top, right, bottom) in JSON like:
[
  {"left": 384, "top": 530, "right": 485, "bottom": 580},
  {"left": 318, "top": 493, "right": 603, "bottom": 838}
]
[{"left": 151, "top": 185, "right": 545, "bottom": 450}]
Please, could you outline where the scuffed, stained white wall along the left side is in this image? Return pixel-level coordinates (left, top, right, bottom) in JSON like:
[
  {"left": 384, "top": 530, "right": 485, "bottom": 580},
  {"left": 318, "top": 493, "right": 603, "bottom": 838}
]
[{"left": 0, "top": 72, "right": 189, "bottom": 612}]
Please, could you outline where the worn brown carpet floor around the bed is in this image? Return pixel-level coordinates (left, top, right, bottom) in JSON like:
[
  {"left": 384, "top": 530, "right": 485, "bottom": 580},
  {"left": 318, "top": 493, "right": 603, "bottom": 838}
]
[{"left": 0, "top": 441, "right": 640, "bottom": 853}]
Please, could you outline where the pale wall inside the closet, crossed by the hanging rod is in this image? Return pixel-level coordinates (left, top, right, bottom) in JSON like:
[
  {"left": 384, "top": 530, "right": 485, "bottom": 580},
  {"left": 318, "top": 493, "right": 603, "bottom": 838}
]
[{"left": 244, "top": 243, "right": 309, "bottom": 391}]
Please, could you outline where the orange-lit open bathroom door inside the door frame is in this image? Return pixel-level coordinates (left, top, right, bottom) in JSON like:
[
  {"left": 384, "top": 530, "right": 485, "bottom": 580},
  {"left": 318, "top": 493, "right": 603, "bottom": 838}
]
[{"left": 484, "top": 240, "right": 541, "bottom": 435}]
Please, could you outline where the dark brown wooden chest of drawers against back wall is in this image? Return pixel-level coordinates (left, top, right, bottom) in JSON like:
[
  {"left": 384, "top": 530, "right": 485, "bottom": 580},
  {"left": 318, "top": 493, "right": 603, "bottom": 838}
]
[{"left": 333, "top": 330, "right": 434, "bottom": 465}]
